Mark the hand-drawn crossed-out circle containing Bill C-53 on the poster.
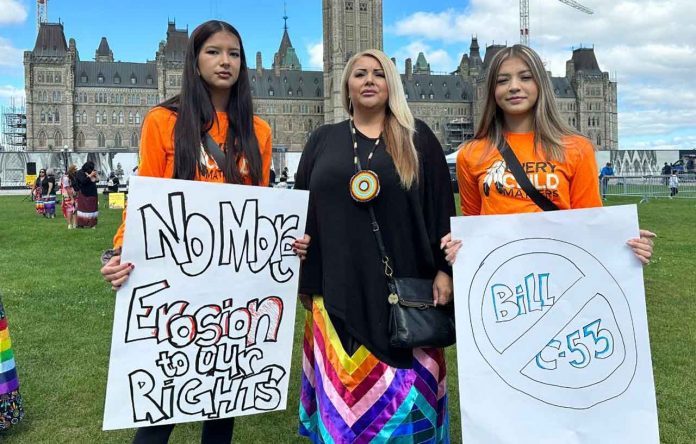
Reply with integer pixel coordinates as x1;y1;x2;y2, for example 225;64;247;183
469;238;637;409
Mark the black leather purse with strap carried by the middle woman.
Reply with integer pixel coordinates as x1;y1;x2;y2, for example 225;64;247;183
368;205;456;349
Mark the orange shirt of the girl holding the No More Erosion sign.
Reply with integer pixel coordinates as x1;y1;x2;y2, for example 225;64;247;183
114;106;272;248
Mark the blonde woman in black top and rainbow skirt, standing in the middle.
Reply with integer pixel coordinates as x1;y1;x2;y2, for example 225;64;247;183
295;50;454;443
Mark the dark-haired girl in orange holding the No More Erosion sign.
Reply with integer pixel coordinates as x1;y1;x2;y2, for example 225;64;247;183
101;20;308;444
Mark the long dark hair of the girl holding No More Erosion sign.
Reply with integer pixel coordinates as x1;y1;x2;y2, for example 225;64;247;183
160;20;261;185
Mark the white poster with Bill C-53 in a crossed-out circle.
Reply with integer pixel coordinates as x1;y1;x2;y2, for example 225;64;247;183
452;205;659;444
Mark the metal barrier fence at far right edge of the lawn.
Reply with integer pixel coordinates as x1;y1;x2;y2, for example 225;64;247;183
600;173;696;202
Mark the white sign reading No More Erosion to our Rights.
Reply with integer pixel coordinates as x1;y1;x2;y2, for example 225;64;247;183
103;177;309;430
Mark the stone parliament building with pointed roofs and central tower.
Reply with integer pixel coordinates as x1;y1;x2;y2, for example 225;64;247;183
14;0;618;180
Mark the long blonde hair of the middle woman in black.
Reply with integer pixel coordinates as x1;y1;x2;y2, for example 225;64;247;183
341;49;418;189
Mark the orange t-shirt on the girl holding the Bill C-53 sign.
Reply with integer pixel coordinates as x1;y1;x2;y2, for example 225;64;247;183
457;132;602;216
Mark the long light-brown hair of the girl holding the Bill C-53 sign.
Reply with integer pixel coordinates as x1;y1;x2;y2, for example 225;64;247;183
474;44;579;161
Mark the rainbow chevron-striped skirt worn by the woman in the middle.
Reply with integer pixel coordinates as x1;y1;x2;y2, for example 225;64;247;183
299;296;449;443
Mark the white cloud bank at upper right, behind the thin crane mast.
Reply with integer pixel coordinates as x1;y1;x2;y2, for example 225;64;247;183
385;0;696;148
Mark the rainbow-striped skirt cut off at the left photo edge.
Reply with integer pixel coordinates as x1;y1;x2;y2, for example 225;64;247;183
0;299;24;430
